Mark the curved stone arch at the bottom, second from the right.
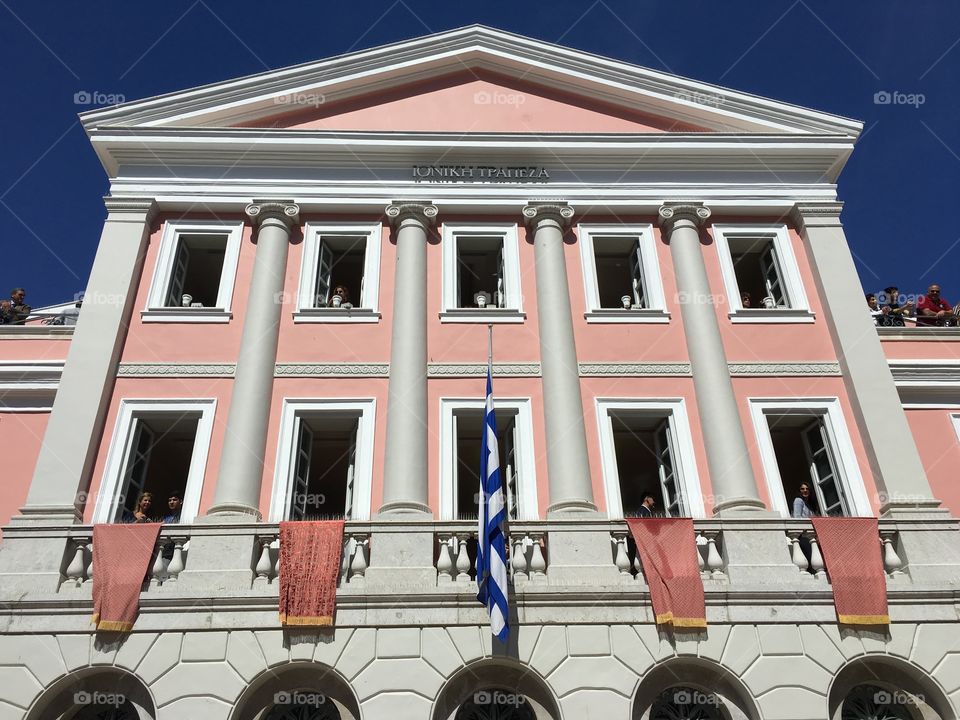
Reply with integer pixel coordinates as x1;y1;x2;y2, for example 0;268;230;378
630;657;760;720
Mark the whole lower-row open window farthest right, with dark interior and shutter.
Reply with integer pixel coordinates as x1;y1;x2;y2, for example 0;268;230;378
750;399;871;517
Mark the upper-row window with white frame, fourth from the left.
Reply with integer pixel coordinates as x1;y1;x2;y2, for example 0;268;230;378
578;224;670;323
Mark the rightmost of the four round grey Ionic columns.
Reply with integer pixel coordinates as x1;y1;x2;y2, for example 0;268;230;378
659;204;764;515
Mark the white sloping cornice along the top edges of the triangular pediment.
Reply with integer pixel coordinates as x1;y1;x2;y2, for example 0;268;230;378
81;25;862;138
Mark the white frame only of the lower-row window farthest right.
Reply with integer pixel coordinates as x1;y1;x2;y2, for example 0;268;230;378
748;397;874;518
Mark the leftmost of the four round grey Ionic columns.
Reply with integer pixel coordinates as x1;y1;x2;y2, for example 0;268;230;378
208;200;300;520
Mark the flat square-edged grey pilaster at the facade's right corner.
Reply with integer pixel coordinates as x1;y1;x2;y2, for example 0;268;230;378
794;202;940;515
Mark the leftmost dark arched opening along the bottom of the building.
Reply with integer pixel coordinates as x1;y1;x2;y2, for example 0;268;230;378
24;667;157;720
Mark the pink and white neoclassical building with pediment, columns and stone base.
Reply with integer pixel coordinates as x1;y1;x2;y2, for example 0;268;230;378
0;27;960;720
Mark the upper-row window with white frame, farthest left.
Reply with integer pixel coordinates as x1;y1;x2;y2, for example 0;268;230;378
142;221;243;322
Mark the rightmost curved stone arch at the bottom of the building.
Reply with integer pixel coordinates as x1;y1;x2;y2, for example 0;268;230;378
827;655;957;720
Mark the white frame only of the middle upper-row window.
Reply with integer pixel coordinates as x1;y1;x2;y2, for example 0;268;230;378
440;223;526;323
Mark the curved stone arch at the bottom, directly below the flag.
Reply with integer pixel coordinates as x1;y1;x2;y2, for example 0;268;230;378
430;658;563;720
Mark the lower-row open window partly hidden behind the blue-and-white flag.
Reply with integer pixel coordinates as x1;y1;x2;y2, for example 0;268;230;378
440;399;539;520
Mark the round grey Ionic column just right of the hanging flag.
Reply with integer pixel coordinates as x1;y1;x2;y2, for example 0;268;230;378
523;202;597;515
